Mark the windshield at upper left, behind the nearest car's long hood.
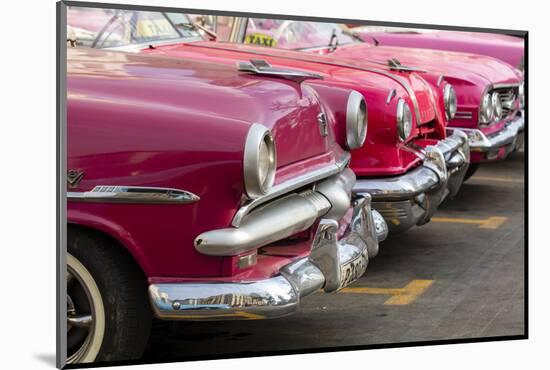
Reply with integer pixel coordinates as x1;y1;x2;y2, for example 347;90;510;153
67;7;202;48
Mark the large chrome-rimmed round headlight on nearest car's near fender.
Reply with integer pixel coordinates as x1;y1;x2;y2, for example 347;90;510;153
243;123;277;198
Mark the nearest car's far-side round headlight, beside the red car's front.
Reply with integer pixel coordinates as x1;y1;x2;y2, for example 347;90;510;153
346;91;368;149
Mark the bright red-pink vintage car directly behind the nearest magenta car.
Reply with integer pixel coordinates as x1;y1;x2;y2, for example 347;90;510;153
69;7;469;237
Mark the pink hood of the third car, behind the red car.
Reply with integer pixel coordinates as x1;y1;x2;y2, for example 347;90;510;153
335;44;519;86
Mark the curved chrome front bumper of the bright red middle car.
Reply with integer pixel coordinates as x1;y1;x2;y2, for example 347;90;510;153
353;146;453;233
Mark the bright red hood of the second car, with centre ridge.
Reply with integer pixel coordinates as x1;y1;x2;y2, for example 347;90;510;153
143;42;437;123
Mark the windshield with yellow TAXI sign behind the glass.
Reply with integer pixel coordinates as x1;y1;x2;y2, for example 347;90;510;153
244;18;359;49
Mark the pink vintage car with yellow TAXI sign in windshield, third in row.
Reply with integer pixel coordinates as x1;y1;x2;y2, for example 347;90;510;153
230;18;524;178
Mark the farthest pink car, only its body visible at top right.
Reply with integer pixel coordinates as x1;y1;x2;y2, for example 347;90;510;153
350;25;525;71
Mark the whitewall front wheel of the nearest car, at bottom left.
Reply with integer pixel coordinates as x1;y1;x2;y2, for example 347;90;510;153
67;232;152;364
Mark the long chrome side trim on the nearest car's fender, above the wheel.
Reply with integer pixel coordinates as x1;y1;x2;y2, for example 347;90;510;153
67;185;200;204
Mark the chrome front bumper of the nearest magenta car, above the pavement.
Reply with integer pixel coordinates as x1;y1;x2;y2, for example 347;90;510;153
149;195;384;320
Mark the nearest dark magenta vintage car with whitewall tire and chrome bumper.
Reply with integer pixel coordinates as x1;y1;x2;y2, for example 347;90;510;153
67;44;387;363
